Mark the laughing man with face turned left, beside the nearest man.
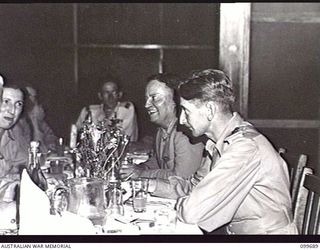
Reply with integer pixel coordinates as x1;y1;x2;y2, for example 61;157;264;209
122;73;203;180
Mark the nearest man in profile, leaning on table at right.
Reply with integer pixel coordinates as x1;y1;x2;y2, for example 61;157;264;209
168;69;297;234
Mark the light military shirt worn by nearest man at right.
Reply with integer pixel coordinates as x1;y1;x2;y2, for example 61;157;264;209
177;113;297;234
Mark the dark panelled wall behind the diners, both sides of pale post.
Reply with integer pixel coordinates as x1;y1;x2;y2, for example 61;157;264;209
0;3;320;174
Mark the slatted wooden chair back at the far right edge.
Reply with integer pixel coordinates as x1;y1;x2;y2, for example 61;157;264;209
301;174;320;234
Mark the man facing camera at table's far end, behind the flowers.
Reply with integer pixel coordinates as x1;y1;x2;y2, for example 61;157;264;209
76;77;138;141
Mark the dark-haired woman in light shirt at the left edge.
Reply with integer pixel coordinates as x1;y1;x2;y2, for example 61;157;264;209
0;85;30;201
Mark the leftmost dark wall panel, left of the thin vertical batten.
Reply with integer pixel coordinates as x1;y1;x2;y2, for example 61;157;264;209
0;4;74;140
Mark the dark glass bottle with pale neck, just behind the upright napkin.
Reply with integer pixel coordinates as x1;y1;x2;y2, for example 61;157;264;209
28;141;48;190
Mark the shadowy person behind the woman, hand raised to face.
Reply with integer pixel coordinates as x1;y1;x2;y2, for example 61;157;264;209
17;86;58;152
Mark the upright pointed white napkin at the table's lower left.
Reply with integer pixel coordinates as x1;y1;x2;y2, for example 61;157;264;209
19;169;96;235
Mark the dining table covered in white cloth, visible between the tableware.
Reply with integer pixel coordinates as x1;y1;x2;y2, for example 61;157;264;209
7;148;202;235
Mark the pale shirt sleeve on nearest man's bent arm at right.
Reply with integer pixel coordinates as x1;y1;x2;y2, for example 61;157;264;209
177;138;260;231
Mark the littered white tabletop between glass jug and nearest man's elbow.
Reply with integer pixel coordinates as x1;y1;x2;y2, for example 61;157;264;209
96;195;202;235
